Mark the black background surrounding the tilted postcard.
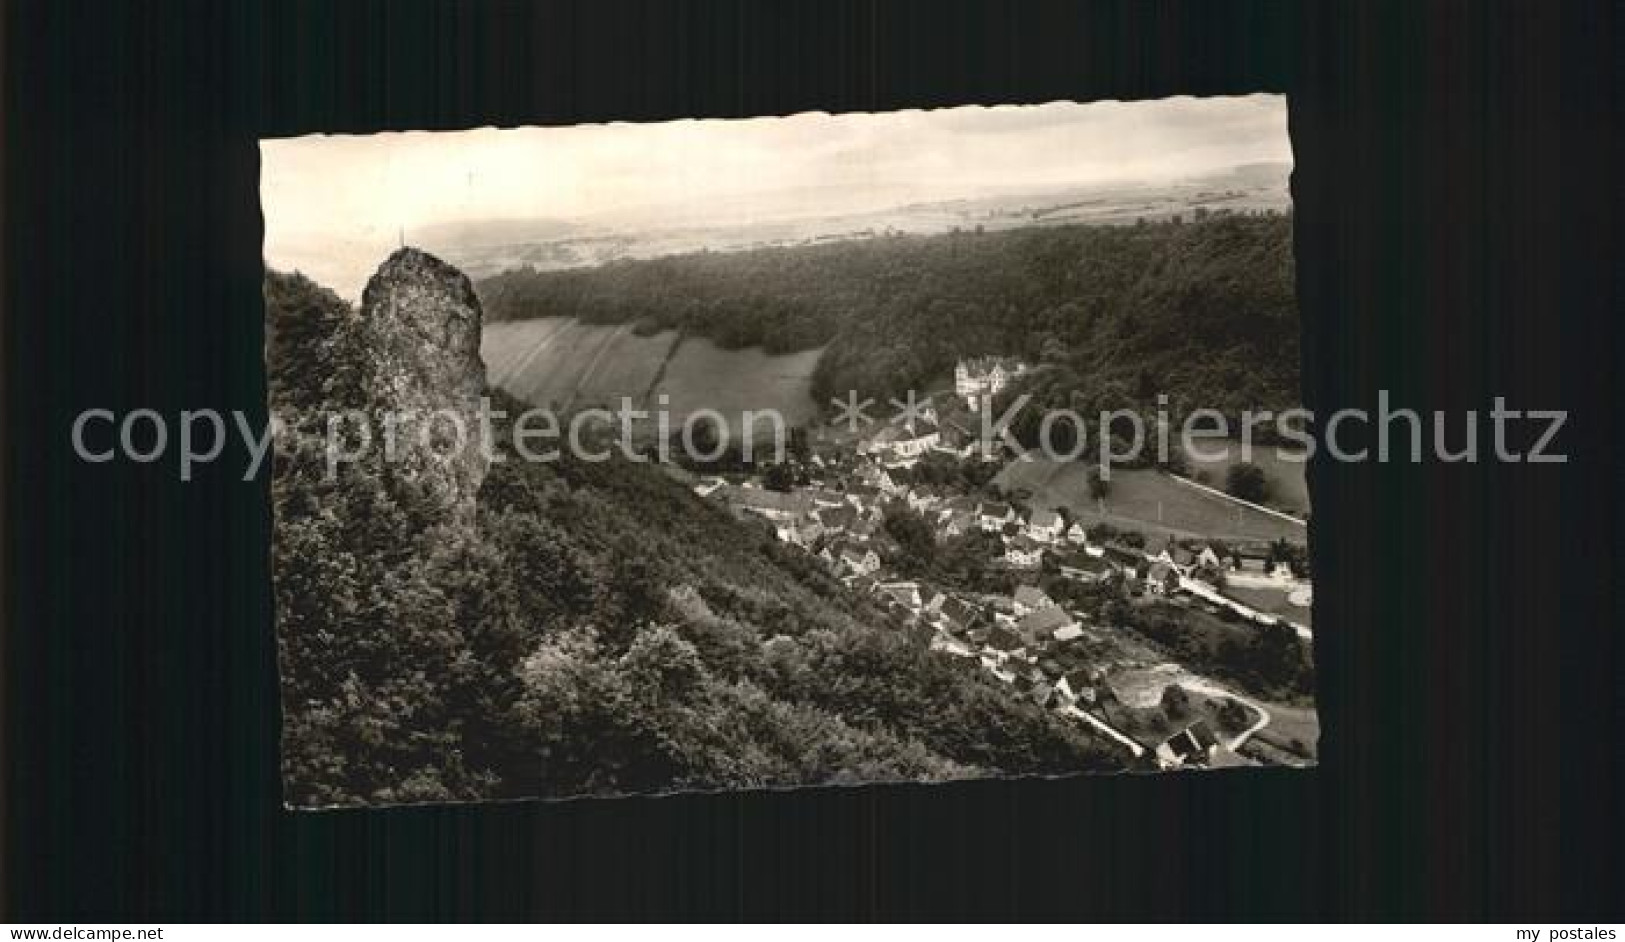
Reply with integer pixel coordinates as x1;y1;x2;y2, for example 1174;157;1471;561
3;0;1625;921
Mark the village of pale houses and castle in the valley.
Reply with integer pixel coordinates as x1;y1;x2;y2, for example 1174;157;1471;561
692;357;1318;768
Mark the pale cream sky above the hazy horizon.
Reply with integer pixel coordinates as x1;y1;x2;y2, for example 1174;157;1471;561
260;94;1292;293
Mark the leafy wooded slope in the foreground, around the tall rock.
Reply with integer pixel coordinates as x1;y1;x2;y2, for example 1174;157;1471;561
265;266;1118;806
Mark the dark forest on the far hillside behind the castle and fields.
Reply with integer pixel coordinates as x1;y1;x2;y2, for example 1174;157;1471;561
479;214;1300;416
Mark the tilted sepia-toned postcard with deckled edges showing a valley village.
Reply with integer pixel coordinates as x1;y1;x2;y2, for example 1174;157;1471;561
260;94;1320;807
